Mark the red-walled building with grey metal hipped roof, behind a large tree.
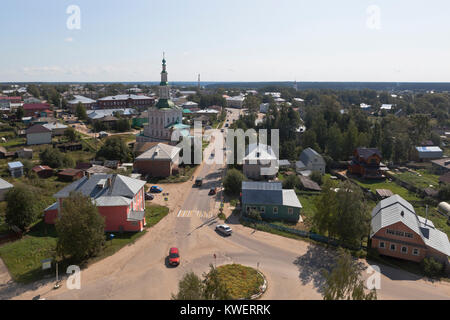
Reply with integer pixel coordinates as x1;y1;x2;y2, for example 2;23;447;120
44;174;146;232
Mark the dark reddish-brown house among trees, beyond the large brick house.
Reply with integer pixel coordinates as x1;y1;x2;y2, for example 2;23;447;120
348;148;383;179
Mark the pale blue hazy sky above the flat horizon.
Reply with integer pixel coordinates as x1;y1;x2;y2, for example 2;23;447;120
0;0;450;83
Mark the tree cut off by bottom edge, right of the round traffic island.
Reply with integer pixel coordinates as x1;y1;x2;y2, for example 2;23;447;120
322;248;377;300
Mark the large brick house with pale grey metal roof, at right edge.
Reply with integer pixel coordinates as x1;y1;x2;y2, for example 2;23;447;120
370;195;450;268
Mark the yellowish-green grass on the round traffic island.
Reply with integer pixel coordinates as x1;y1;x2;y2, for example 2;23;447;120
217;264;264;300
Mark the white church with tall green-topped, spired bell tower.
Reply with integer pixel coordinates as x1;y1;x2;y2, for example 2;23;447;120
136;57;189;144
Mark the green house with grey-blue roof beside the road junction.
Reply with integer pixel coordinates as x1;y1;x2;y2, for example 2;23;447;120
242;181;302;222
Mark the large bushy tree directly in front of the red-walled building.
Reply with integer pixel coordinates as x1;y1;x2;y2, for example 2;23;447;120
55;193;105;262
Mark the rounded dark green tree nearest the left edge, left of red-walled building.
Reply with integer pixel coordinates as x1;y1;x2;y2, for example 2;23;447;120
5;184;40;230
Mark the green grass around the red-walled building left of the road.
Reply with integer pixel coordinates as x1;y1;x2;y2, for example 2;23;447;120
0;205;169;283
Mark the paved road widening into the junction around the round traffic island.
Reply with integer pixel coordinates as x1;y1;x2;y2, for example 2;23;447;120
0;107;450;300
